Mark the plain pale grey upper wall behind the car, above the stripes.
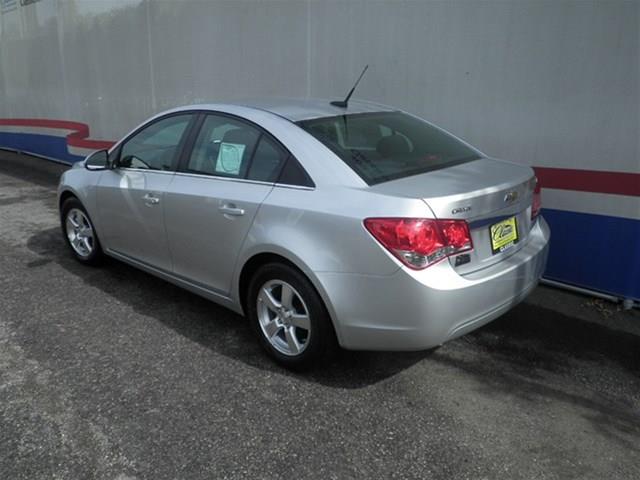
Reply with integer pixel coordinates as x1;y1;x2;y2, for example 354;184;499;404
0;0;640;172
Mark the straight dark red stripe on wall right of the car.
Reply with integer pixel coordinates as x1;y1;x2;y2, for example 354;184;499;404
533;167;640;197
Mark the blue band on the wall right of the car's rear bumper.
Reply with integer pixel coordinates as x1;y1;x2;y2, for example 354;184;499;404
542;208;640;300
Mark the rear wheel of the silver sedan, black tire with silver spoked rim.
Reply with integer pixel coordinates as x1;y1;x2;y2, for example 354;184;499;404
246;263;337;370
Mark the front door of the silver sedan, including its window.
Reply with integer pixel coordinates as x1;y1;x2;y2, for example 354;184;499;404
97;113;195;271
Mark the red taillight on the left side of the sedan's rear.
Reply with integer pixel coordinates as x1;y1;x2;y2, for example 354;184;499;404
364;218;473;269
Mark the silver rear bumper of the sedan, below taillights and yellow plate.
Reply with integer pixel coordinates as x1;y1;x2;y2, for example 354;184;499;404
317;217;550;350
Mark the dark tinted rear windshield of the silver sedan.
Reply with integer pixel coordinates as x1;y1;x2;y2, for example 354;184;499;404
298;112;480;185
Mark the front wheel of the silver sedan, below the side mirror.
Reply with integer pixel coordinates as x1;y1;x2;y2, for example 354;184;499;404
60;197;104;265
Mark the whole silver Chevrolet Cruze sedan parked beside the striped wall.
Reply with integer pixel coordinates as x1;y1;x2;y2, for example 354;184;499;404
58;100;549;368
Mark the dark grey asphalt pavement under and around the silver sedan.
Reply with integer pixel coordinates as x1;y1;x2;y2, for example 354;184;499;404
0;152;640;480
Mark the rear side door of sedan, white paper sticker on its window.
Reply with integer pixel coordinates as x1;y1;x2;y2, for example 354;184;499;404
165;114;287;295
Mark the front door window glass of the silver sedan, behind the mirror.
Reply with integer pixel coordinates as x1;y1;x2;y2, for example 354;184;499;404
118;114;192;170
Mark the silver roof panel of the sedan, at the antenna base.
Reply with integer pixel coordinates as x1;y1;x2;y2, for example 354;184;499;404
174;98;397;122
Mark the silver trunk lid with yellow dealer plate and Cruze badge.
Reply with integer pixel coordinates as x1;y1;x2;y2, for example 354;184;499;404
372;158;535;275
